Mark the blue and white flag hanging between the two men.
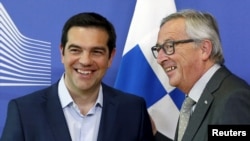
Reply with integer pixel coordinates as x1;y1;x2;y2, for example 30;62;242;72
115;0;184;139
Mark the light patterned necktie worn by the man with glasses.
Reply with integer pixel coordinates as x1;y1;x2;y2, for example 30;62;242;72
178;96;195;141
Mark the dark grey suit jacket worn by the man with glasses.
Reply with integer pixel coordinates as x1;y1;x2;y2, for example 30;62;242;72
156;66;250;141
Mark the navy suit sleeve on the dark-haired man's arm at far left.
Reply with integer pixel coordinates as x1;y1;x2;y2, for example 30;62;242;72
0;100;24;141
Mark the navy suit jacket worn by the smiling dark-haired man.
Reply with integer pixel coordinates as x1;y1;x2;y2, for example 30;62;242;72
1;83;153;141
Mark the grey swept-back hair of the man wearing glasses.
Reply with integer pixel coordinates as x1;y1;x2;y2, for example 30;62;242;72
160;9;225;65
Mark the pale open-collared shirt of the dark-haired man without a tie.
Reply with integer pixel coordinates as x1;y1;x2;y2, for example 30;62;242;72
58;75;103;141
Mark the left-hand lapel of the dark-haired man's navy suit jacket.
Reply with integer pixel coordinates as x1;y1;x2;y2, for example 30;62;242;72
44;83;71;141
